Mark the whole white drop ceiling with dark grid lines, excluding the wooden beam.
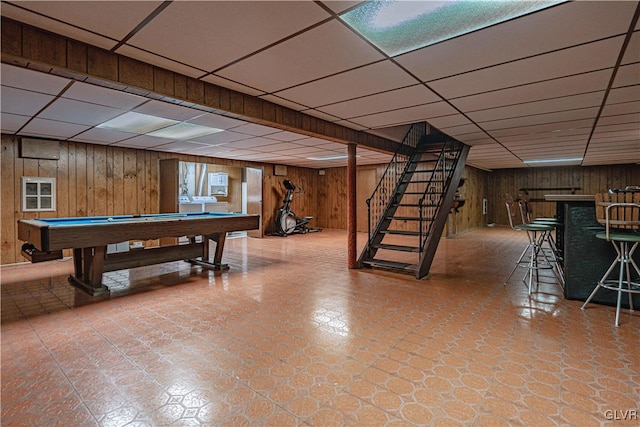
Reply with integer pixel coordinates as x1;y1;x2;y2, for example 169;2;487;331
1;1;640;169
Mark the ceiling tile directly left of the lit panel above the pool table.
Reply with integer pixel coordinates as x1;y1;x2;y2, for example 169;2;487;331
38;98;125;126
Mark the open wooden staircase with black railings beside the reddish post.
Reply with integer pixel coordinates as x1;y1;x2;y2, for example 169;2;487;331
358;123;469;279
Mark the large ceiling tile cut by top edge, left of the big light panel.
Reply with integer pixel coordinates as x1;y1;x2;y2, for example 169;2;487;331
129;1;330;72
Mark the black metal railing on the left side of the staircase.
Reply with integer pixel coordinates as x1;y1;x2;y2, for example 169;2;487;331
366;122;427;256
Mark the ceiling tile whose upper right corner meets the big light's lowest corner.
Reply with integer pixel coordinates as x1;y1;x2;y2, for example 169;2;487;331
276;61;416;108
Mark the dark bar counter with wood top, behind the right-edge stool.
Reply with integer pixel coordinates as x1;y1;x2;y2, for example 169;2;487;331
545;194;640;308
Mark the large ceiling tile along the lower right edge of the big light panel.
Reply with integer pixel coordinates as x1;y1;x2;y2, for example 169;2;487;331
395;2;635;83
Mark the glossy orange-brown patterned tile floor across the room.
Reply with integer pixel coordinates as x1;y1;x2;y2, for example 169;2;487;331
1;228;640;427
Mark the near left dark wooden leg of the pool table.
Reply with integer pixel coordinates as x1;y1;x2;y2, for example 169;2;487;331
69;246;109;296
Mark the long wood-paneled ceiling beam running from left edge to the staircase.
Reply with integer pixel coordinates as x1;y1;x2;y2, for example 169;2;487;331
1;17;398;153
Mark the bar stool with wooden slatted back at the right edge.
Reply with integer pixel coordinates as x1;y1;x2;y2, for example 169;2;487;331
581;193;640;326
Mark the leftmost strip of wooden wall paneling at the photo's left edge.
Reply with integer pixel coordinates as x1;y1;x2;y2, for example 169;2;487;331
0;136;18;264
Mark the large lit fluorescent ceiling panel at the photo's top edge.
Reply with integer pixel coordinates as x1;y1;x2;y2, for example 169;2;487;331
340;0;564;56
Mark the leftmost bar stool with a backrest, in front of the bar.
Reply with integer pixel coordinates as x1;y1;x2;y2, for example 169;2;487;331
504;194;553;295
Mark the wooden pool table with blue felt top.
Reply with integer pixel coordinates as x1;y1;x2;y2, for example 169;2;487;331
18;212;260;295
